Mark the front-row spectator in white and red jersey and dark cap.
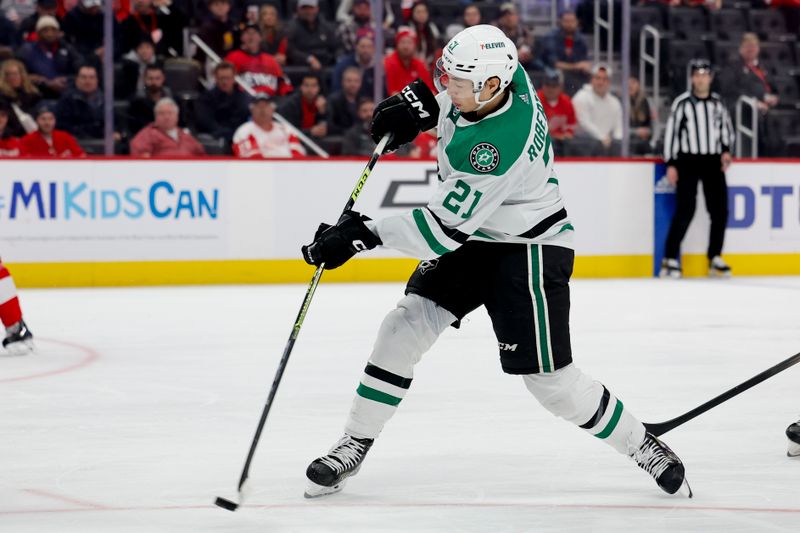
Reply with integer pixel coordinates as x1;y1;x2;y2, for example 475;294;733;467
233;93;306;158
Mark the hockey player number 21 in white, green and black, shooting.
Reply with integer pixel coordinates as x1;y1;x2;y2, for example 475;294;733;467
302;25;691;497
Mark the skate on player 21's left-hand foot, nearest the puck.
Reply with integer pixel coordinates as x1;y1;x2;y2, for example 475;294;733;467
305;433;373;498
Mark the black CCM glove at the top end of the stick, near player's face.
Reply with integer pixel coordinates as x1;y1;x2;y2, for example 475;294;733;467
370;78;439;152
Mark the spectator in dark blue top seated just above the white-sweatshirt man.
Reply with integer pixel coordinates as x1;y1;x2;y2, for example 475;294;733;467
541;11;592;92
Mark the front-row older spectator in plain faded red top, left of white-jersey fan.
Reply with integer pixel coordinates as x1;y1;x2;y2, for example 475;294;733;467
131;98;206;157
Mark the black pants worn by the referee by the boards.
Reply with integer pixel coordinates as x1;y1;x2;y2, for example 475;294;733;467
664;155;728;259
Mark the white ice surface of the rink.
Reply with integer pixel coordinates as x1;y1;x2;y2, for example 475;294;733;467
0;278;800;533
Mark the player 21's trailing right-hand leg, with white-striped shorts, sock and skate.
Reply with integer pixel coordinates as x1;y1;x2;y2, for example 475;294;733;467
487;245;691;494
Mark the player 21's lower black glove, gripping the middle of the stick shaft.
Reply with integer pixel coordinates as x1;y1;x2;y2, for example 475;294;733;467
301;211;383;270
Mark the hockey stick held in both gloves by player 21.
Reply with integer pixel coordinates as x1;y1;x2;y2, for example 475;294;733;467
214;134;390;511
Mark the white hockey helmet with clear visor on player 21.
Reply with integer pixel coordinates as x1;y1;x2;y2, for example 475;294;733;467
434;24;518;109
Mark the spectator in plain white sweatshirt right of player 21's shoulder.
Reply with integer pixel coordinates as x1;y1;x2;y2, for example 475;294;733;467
572;63;622;155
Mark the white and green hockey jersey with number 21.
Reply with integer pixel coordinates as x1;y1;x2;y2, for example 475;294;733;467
367;66;574;259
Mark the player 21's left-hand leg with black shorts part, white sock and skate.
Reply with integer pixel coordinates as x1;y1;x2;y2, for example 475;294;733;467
305;249;478;498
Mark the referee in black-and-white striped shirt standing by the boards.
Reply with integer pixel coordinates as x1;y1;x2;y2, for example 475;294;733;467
659;59;734;278
